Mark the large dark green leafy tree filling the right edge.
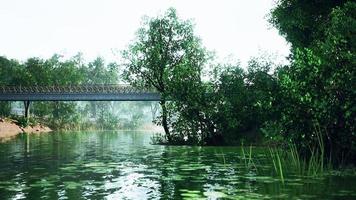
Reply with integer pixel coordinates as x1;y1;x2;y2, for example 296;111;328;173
272;0;356;163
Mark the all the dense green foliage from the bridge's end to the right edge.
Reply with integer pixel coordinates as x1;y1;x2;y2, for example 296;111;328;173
124;5;356;167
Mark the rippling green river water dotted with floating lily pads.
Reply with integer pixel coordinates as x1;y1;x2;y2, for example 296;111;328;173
0;131;356;200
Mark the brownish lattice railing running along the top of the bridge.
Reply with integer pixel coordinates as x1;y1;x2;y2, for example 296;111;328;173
0;84;156;94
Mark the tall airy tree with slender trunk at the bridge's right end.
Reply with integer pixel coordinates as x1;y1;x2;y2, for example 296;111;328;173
123;9;207;141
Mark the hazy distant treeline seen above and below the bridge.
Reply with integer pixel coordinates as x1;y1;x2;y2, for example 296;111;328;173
0;54;156;129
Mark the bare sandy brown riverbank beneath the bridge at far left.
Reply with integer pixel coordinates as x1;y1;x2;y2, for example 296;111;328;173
0;118;52;140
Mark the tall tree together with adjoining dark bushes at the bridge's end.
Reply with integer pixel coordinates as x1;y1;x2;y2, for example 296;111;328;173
123;9;277;145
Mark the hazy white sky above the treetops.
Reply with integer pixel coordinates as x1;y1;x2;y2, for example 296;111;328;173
0;0;289;64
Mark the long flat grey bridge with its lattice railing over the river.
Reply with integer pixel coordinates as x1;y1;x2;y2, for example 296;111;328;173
0;85;160;101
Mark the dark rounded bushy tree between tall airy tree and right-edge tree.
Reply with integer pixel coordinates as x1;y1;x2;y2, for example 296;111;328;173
212;56;278;143
